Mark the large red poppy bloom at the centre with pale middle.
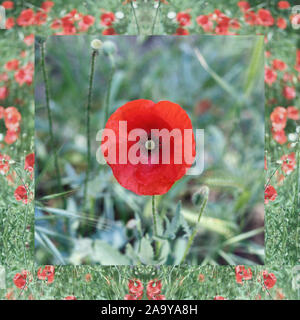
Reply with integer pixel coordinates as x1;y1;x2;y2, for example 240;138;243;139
101;99;196;195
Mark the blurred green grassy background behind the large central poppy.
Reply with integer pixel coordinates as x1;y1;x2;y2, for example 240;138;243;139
35;36;264;265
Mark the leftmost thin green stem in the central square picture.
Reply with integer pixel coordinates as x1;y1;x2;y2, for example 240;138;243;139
40;39;66;209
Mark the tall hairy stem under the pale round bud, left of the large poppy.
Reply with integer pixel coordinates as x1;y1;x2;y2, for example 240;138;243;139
83;49;98;207
